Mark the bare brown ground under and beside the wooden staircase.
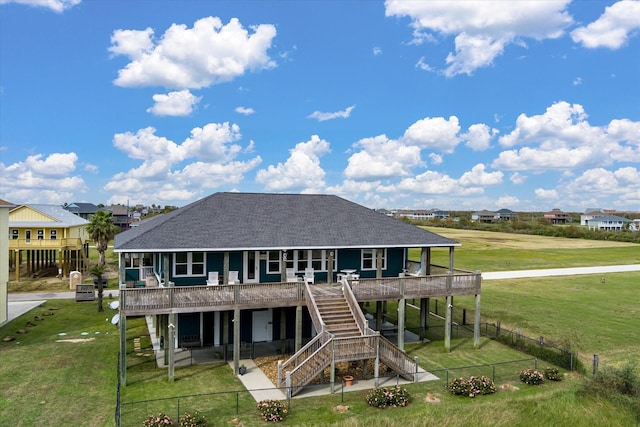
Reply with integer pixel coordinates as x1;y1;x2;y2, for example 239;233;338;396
254;355;390;384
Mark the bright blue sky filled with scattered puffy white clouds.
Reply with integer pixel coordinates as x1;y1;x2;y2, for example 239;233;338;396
0;0;640;211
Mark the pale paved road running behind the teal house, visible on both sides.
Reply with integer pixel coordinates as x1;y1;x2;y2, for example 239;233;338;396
2;264;640;320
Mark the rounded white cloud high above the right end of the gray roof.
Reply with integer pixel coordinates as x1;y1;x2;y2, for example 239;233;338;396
401;116;460;153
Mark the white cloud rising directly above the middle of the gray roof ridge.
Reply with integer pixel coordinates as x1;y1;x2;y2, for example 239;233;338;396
256;135;330;192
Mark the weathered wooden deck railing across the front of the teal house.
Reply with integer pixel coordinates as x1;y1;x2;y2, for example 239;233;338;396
120;273;481;316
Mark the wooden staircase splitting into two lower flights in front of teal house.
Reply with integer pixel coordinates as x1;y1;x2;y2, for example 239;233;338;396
277;284;418;395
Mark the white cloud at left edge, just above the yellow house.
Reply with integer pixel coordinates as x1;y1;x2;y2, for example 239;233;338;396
0;153;86;204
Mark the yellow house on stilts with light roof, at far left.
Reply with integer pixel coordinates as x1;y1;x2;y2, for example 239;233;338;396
9;204;89;281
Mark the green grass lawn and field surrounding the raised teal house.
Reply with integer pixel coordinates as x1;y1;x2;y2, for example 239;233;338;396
0;229;640;427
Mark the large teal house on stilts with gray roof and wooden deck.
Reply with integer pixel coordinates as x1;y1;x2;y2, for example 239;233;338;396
114;193;481;392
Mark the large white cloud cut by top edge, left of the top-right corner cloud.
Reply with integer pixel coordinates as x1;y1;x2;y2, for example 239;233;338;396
385;0;573;77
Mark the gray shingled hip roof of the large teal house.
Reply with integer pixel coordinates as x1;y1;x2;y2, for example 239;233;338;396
114;193;460;252
